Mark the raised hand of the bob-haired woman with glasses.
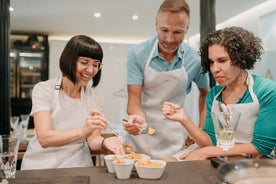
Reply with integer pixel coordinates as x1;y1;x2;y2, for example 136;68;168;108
82;109;109;137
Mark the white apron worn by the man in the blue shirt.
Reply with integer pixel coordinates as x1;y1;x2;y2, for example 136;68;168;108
128;41;188;159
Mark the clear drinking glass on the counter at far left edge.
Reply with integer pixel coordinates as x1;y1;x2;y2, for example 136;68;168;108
0;135;19;179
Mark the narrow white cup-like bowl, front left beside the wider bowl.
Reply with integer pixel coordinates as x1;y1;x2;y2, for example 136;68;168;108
113;159;134;179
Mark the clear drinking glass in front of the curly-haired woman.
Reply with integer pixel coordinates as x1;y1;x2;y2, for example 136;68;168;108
211;111;241;158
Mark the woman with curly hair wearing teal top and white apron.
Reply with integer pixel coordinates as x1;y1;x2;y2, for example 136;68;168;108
162;27;276;160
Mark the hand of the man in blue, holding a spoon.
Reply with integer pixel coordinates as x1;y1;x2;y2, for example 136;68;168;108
123;115;148;135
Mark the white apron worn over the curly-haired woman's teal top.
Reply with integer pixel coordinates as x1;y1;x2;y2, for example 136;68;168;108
211;73;260;144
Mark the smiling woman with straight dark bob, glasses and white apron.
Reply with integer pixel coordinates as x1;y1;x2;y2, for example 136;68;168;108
21;35;124;170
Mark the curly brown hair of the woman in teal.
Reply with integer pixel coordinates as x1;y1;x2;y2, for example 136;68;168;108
200;27;264;73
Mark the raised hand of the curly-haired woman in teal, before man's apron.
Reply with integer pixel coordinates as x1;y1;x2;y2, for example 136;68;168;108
162;101;188;122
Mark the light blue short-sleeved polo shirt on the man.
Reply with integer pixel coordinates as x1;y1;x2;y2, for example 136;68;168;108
127;36;209;93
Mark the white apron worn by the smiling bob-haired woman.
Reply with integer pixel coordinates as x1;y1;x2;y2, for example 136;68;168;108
22;77;93;169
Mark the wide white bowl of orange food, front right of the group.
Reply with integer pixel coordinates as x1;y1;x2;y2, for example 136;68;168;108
135;160;166;179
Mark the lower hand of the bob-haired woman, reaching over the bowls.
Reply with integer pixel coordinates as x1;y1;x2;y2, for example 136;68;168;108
103;136;125;155
